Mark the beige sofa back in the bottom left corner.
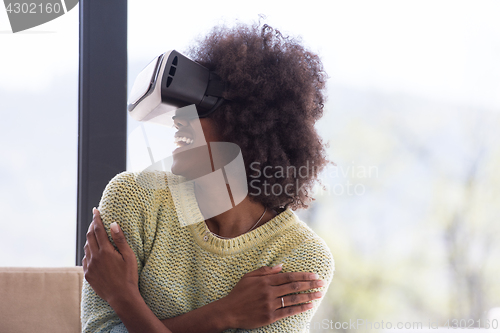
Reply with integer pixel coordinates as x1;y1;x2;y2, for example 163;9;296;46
0;266;83;333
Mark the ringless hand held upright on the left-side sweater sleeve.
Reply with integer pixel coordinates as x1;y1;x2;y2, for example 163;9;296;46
82;208;139;304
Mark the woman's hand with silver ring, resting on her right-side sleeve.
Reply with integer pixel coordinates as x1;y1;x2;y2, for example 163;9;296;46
221;265;325;329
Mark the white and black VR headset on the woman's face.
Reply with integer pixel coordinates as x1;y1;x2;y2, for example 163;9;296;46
128;50;226;126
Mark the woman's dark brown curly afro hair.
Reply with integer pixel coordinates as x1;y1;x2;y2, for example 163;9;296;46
188;23;329;212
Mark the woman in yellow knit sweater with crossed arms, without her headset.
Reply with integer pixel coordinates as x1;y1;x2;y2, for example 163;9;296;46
82;21;334;332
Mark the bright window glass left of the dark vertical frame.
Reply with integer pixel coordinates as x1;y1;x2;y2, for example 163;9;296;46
0;6;78;266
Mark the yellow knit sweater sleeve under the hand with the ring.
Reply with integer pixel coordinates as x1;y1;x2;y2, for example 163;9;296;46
232;238;335;333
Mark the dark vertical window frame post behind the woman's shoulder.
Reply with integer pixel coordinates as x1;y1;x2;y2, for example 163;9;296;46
76;0;127;266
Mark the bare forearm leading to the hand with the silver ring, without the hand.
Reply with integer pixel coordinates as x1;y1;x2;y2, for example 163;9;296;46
161;299;231;333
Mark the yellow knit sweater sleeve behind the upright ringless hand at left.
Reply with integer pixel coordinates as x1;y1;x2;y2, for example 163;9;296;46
81;173;155;333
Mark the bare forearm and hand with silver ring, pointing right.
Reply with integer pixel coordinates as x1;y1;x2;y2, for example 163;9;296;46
156;265;324;333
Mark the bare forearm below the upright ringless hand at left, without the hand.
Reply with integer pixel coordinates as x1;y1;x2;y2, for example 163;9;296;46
109;291;172;333
